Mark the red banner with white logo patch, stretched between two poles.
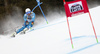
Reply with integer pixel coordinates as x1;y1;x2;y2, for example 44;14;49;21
63;0;89;17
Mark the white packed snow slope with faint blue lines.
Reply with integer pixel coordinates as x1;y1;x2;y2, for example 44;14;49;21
0;6;100;54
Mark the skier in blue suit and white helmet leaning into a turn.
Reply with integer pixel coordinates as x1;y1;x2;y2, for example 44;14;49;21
11;8;35;37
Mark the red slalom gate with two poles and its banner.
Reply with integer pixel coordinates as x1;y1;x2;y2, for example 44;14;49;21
63;0;98;48
